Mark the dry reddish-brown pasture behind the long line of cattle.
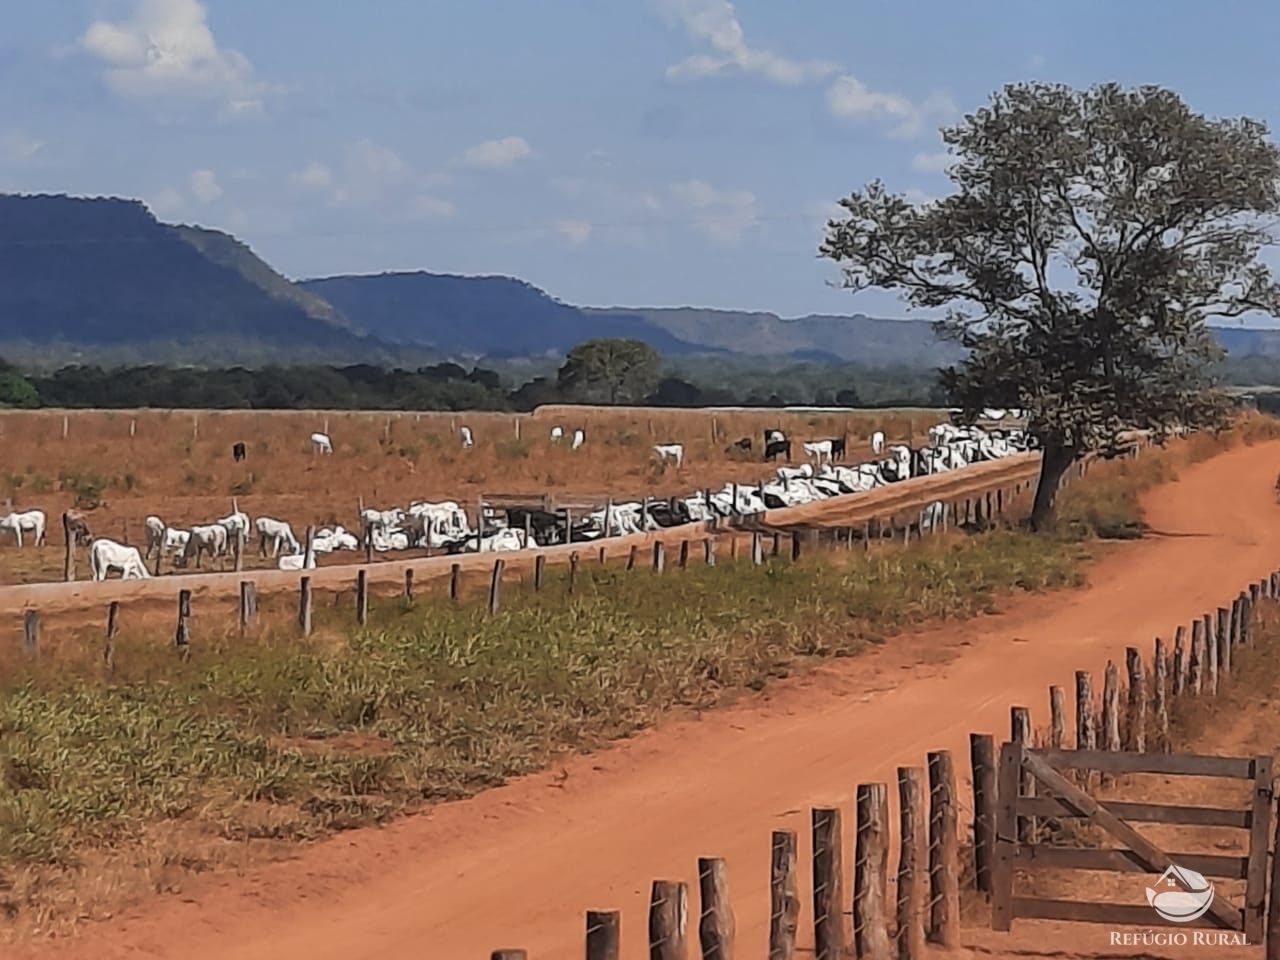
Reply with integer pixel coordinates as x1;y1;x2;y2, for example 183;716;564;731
0;407;947;584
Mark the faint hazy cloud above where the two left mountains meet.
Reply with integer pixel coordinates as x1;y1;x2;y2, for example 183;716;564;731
288;140;456;220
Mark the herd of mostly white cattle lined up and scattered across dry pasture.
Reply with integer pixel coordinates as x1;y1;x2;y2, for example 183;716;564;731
0;411;1036;580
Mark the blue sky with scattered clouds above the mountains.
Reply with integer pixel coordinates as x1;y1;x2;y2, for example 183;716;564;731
0;0;1280;323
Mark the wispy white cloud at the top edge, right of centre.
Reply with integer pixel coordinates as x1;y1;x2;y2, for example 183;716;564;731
654;0;840;87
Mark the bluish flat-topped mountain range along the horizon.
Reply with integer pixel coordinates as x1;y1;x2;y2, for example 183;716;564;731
0;195;1280;367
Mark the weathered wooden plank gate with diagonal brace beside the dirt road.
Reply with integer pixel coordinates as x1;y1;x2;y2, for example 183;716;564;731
991;742;1272;943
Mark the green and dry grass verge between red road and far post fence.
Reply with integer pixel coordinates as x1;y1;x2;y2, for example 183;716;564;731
0;433;1252;937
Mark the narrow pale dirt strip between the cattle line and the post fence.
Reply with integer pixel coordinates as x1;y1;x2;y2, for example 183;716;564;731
0;453;1059;608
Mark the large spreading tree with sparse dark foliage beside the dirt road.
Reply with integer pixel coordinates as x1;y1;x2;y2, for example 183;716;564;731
819;83;1280;530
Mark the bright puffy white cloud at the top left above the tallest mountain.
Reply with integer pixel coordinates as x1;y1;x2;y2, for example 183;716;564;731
79;0;266;114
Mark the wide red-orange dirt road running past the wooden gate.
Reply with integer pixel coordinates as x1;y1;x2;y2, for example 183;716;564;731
10;443;1280;960
